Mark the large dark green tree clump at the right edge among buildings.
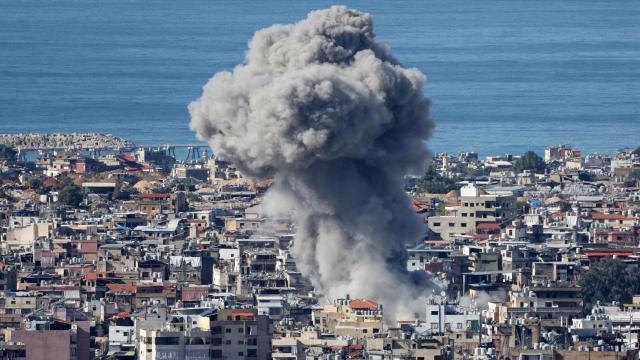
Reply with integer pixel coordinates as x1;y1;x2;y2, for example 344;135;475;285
579;258;640;309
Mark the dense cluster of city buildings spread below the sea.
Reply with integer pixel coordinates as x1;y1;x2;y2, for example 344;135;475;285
0;136;640;360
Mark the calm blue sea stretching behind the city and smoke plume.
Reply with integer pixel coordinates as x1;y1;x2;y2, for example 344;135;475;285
0;0;640;155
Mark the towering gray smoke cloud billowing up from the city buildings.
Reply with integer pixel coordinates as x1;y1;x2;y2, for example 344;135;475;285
189;6;435;319
